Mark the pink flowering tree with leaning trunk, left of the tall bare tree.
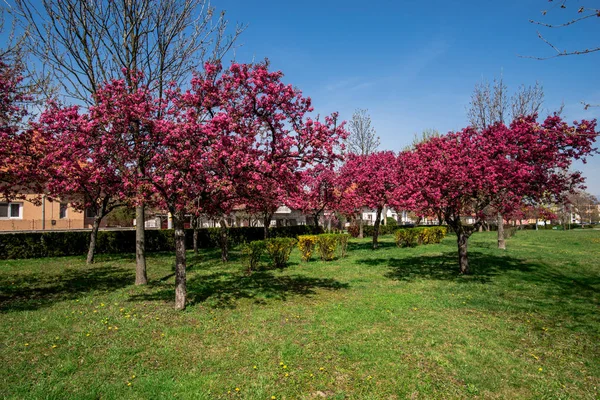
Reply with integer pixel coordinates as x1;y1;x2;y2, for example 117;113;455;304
32;103;125;264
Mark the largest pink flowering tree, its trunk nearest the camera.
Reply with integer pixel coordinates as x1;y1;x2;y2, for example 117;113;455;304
83;64;346;309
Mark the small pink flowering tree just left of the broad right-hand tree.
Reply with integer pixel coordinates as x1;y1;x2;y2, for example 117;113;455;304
339;151;403;249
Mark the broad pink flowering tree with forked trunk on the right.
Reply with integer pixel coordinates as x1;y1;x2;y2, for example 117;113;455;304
406;116;597;274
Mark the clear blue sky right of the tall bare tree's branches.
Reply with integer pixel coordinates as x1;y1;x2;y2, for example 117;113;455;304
219;0;600;195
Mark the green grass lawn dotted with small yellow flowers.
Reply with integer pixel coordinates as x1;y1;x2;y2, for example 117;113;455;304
0;230;600;399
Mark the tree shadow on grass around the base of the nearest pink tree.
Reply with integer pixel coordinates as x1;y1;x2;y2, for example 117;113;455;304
130;271;349;308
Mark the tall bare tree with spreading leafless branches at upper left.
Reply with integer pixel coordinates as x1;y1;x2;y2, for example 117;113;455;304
12;0;245;284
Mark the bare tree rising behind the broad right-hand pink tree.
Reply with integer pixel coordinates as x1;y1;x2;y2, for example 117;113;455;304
467;75;548;249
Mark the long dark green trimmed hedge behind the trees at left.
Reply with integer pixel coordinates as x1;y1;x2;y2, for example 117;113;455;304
0;225;322;260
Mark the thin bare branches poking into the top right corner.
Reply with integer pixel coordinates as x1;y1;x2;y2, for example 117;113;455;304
525;0;600;60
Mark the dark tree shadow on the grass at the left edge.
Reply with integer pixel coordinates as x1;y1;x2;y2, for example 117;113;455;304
0;266;134;313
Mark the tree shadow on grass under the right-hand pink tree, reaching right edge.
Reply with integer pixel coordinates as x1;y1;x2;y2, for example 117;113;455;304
358;251;600;332
